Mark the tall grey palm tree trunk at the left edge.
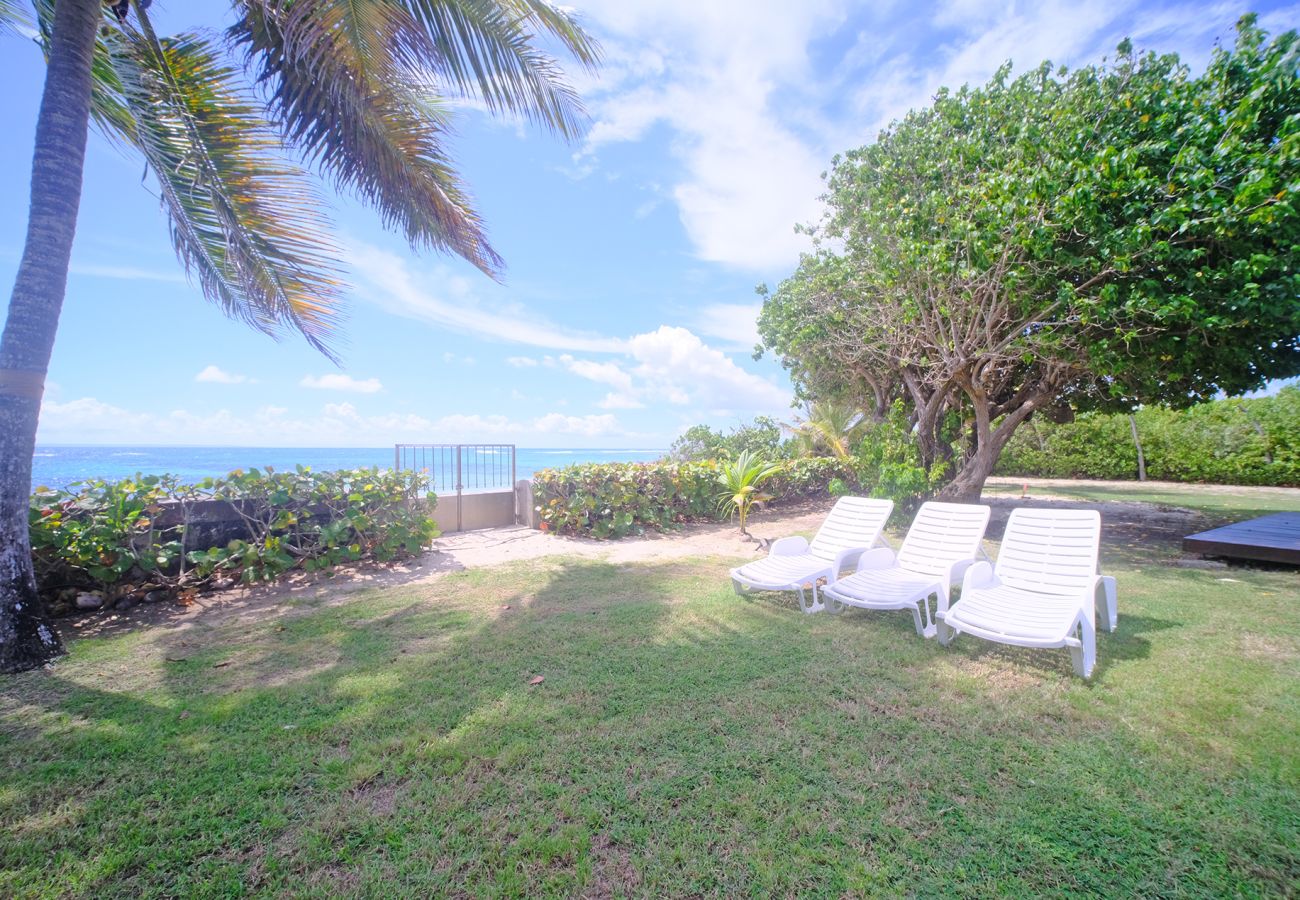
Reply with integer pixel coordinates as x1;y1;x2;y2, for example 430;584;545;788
0;0;104;672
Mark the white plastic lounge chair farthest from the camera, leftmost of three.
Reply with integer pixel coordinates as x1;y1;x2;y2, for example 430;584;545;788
731;497;893;613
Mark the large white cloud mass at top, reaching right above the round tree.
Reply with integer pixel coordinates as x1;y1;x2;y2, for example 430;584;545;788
577;0;1268;273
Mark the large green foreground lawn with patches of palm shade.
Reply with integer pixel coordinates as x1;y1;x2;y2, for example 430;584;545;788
0;522;1300;897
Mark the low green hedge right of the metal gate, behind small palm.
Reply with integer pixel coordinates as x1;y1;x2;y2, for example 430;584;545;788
533;458;857;538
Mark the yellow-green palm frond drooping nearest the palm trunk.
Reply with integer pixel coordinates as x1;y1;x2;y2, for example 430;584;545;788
96;20;341;359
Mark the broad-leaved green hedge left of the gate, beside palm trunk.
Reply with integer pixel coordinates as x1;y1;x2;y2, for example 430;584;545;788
29;466;438;608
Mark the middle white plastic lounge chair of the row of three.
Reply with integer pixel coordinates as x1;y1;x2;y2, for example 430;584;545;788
822;502;991;637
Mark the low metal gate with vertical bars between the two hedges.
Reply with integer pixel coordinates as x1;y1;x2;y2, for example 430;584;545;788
393;443;519;531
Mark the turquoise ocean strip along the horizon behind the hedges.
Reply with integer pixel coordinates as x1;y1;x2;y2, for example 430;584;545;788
31;445;667;488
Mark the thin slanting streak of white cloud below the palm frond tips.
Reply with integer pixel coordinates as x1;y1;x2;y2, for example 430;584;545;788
348;242;621;352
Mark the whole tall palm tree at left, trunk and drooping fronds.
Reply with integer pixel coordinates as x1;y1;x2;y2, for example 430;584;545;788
0;0;599;672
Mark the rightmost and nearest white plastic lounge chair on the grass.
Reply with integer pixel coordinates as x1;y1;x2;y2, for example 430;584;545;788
935;509;1114;678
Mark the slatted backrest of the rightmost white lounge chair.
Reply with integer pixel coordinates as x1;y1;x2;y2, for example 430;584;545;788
993;509;1101;596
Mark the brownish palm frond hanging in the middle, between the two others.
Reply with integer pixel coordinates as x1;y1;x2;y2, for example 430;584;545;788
229;0;502;277
